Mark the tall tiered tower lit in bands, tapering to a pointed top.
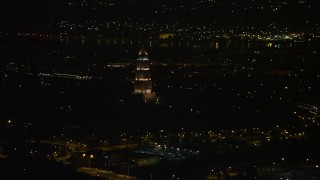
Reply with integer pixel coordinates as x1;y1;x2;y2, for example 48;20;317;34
134;48;156;101
